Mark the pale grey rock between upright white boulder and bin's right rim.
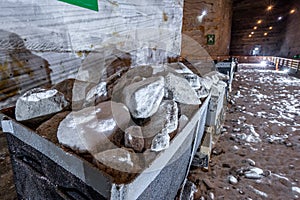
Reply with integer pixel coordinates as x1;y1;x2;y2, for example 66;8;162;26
165;73;201;105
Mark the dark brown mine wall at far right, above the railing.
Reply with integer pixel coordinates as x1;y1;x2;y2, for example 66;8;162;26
279;0;300;58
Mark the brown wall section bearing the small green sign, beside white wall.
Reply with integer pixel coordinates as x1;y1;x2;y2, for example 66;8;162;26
182;0;232;59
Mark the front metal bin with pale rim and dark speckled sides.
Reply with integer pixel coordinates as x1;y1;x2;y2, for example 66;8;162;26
0;96;210;200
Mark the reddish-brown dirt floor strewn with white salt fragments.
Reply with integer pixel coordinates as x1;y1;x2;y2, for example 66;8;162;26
0;65;300;200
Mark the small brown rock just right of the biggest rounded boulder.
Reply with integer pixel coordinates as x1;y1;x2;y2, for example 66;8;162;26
124;126;144;152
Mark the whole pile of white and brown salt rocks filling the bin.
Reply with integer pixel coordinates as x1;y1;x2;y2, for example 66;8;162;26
15;63;228;171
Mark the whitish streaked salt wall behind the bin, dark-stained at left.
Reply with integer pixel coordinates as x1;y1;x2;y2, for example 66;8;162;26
0;0;183;107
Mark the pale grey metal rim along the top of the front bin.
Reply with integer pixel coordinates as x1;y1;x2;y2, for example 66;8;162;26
0;95;210;199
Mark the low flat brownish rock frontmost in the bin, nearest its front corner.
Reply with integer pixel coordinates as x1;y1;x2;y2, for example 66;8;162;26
93;148;141;173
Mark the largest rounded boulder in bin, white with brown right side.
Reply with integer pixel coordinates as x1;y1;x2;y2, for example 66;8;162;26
57;101;131;153
